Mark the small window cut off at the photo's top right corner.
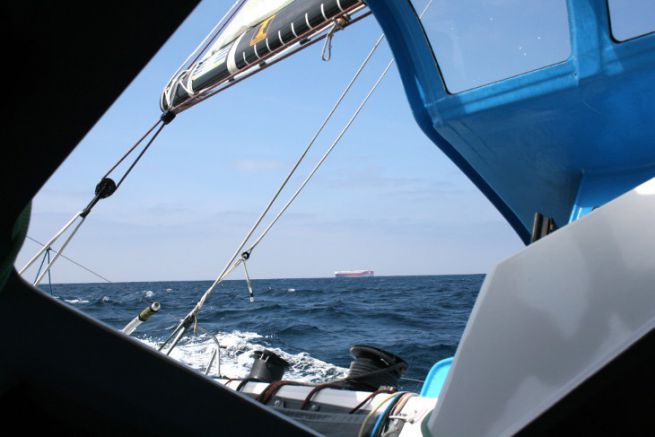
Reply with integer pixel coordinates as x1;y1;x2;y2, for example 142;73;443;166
607;0;655;41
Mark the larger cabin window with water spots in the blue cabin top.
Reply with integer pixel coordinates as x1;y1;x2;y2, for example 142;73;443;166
412;0;572;93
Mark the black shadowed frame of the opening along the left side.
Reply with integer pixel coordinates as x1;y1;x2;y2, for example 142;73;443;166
0;0;313;436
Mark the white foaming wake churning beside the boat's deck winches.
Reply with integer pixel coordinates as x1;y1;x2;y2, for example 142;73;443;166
141;331;348;383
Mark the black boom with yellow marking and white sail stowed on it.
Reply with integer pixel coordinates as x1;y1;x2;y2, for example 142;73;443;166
161;0;363;111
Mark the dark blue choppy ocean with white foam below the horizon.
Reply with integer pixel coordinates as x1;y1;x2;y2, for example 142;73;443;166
43;275;484;391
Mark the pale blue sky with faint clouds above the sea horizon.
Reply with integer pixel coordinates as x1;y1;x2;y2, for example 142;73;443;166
17;1;523;283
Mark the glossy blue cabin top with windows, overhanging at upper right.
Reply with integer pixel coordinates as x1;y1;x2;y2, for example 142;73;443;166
367;0;655;243
